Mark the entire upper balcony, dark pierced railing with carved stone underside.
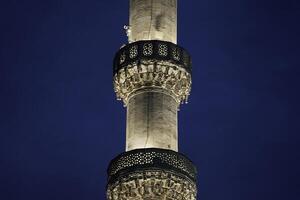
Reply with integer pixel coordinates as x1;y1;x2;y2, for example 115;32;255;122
114;40;191;105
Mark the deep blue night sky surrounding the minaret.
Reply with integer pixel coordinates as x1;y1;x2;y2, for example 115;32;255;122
0;0;300;200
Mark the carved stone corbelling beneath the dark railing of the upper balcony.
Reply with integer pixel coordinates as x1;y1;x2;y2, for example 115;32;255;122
114;60;191;106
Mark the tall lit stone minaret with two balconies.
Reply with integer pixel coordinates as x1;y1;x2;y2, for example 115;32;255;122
107;0;197;200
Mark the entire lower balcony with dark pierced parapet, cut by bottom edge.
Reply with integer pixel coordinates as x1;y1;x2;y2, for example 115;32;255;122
107;148;197;200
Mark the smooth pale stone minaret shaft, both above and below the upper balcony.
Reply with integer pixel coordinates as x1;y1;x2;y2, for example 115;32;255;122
126;0;183;151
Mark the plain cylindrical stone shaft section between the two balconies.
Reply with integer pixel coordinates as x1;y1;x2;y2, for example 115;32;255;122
126;88;178;151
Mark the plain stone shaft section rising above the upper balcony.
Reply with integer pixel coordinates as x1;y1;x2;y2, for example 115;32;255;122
129;0;177;44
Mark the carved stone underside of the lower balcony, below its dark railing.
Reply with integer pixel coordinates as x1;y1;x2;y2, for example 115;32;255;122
107;170;197;200
